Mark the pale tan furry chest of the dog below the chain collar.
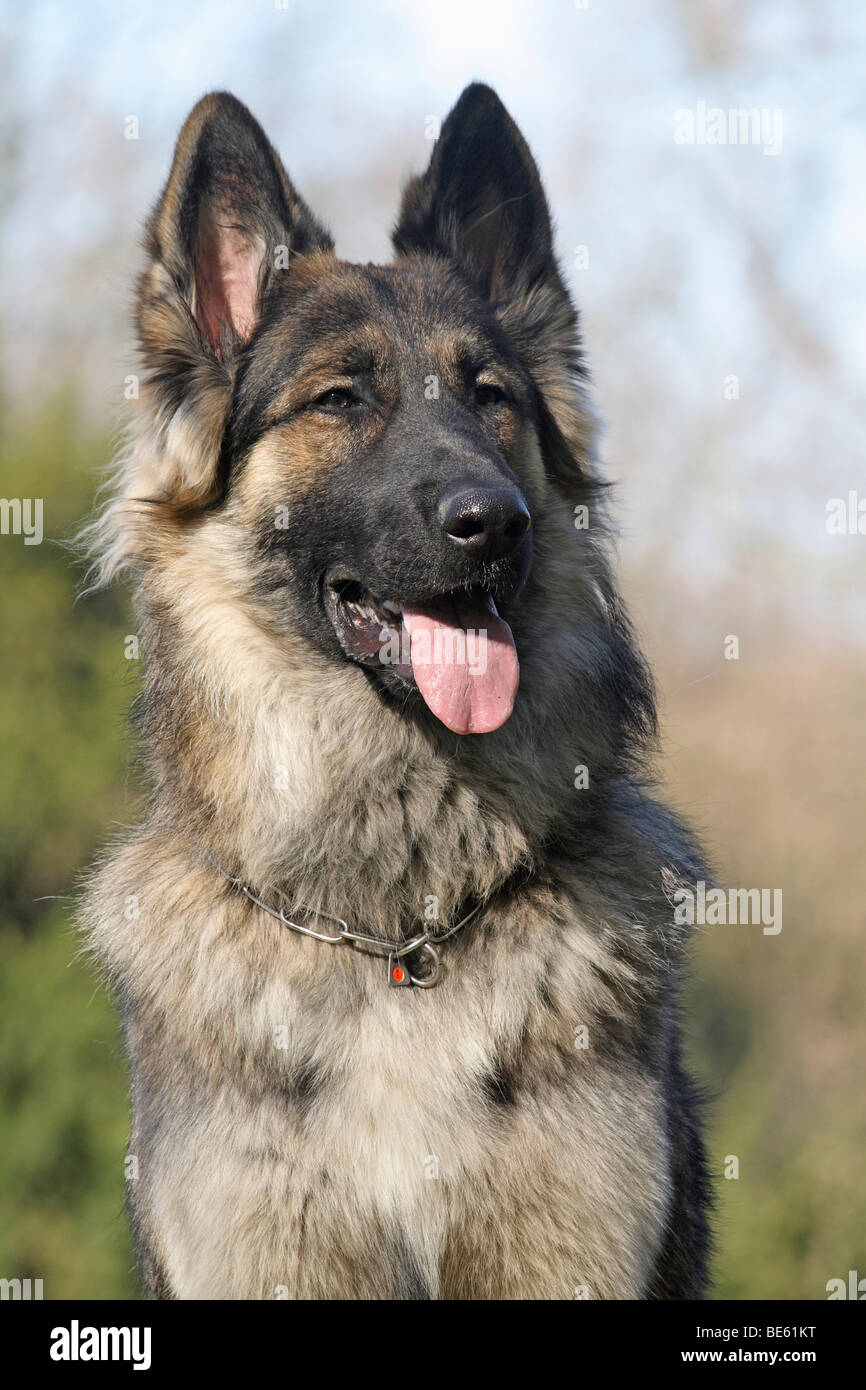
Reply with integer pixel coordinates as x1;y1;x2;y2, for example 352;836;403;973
152;917;667;1297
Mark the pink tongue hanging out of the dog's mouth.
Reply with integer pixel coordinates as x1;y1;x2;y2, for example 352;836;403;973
403;595;520;734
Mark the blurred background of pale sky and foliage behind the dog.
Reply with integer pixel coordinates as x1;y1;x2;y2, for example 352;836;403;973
0;0;866;1298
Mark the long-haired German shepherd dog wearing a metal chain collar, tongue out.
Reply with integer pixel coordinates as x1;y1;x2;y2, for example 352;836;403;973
83;85;709;1300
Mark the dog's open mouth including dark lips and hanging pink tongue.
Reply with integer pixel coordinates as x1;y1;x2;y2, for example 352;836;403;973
324;578;520;734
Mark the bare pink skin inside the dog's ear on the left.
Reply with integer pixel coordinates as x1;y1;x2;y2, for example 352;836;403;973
195;210;263;357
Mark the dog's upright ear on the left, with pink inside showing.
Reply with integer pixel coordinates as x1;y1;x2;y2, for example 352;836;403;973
138;92;334;505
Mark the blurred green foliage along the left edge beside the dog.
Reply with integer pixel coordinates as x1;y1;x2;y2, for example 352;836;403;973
0;399;136;1298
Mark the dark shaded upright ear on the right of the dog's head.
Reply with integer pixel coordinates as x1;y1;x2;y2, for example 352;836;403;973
393;82;594;489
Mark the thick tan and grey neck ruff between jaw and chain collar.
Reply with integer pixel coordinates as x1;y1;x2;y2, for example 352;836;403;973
140;519;647;935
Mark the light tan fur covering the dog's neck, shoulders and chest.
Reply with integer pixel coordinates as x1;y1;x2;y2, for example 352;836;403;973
88;469;683;1298
